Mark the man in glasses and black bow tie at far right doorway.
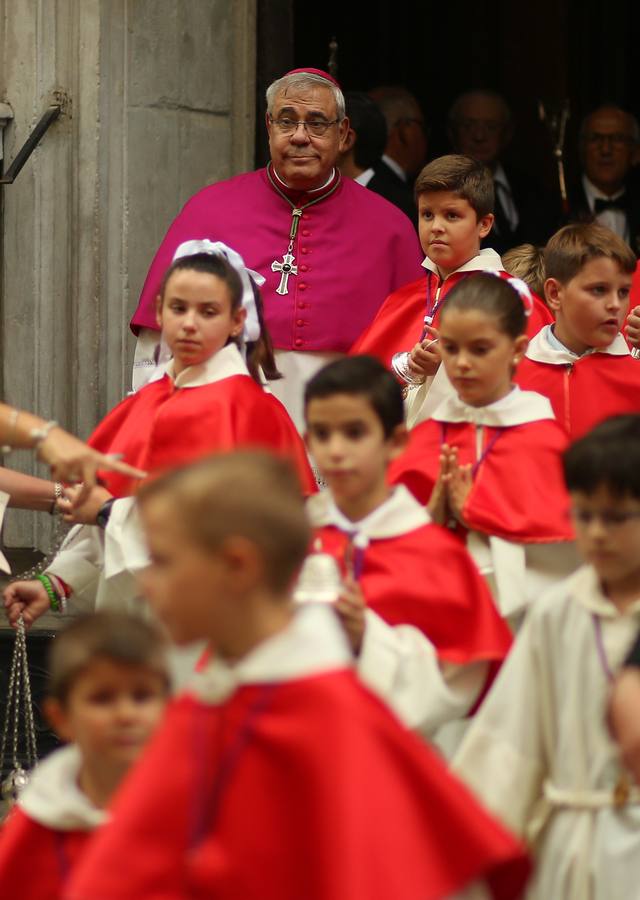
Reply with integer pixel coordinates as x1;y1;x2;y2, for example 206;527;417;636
569;106;640;254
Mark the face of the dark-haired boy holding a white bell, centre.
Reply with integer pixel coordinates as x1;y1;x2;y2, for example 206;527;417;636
306;394;405;515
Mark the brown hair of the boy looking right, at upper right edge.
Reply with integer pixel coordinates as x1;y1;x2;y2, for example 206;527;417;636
544;222;636;284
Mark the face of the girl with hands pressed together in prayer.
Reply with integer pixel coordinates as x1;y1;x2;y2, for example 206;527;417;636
440;308;528;406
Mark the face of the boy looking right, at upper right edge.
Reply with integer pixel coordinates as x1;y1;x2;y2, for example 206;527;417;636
545;256;631;354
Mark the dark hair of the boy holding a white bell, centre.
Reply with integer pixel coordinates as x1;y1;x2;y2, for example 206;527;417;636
304;356;404;438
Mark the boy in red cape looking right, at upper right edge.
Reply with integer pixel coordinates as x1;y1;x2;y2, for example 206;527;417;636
516;223;640;439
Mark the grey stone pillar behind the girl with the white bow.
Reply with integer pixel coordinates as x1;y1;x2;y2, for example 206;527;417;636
0;0;256;547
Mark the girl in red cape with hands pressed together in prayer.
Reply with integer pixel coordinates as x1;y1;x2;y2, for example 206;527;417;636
390;275;578;626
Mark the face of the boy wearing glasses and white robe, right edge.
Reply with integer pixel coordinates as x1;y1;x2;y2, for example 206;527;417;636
571;485;640;596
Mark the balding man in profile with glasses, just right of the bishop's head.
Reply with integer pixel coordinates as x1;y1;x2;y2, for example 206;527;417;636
368;86;427;228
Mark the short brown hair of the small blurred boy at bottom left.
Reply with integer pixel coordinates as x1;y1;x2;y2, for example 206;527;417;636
48;612;170;704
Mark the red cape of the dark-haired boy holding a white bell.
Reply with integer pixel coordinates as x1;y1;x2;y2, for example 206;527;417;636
314;525;511;665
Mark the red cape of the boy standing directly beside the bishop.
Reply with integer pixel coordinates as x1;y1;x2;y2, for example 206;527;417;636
351;271;553;367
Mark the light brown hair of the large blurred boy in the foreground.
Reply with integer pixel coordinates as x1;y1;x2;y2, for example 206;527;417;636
138;450;311;592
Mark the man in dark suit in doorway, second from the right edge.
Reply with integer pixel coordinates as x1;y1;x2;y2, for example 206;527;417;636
448;91;554;254
